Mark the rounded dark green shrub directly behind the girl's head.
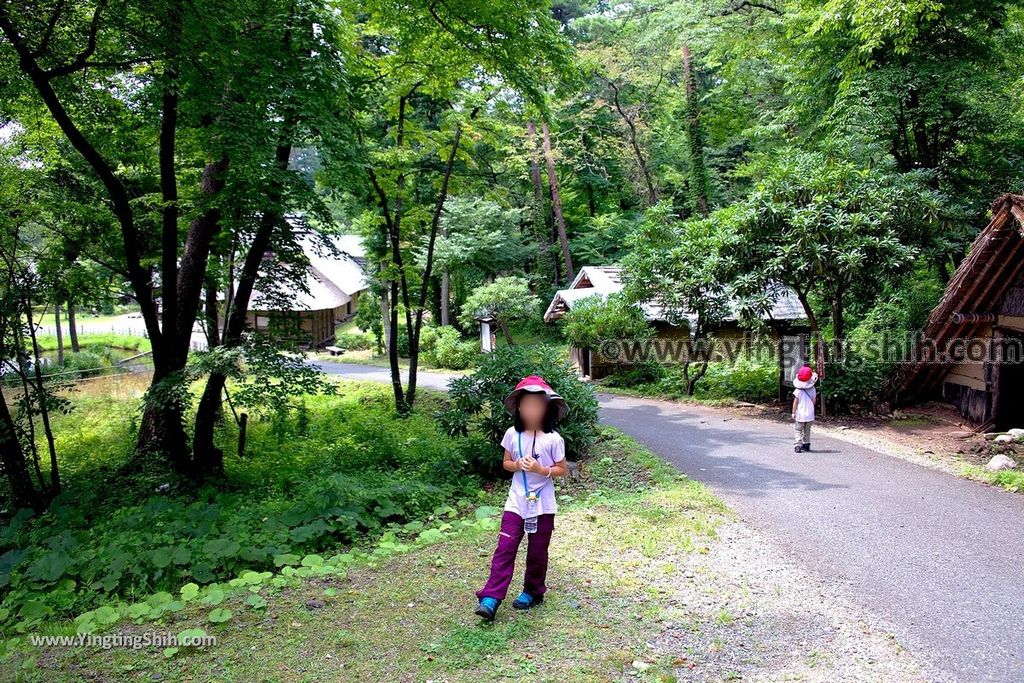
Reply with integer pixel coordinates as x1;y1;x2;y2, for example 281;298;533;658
439;346;597;475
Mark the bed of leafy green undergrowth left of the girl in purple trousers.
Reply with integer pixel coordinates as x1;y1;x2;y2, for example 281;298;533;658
0;385;479;631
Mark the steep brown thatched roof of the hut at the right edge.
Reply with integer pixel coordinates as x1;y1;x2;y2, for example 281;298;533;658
886;195;1024;400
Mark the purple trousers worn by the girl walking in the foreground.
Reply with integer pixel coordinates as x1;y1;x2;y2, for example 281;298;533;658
476;510;555;600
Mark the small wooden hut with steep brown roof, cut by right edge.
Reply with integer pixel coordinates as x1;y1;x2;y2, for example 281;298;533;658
887;195;1024;428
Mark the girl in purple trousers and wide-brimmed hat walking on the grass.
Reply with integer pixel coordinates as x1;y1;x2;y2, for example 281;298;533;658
476;375;568;621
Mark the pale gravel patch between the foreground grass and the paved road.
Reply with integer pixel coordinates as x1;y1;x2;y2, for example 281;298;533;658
645;521;941;683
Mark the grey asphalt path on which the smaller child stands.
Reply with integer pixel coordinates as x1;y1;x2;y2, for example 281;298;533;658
323;364;1024;683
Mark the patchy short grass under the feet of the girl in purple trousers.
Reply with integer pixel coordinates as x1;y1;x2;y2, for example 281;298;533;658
6;428;731;682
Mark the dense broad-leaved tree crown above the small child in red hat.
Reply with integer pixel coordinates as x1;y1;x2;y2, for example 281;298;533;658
715;150;940;337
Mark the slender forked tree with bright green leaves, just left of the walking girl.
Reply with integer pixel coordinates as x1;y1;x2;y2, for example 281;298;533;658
342;0;564;413
